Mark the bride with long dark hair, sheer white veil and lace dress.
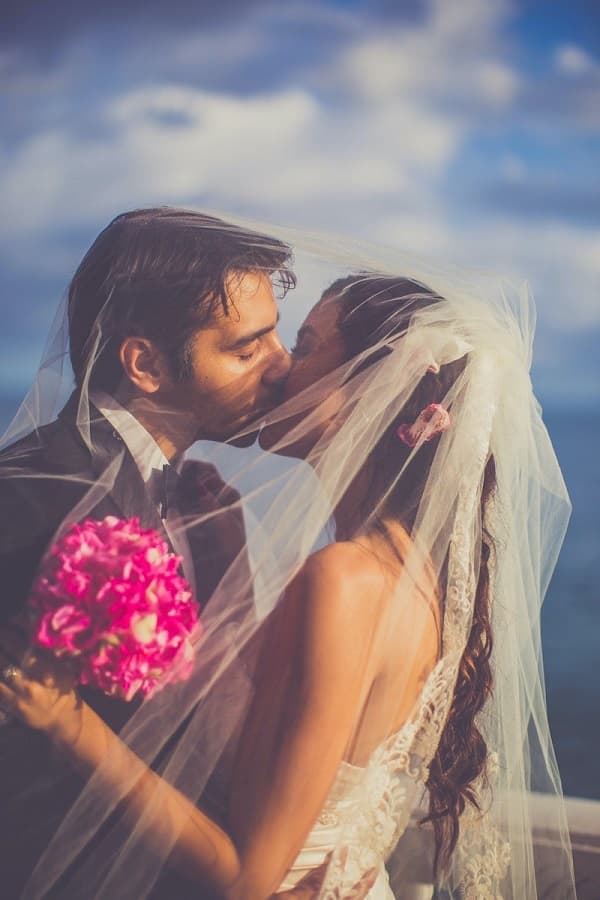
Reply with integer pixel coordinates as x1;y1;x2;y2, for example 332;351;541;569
0;229;575;900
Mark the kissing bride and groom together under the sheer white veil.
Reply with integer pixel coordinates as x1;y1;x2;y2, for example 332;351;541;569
0;208;575;900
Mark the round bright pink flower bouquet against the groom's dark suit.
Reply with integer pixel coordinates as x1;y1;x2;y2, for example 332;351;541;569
30;516;200;700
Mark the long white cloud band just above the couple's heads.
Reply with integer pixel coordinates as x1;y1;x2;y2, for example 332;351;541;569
0;74;462;240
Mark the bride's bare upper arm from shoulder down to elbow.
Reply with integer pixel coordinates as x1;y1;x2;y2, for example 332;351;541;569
231;544;382;897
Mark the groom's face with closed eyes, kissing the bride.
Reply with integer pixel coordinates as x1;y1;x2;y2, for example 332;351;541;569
161;272;290;445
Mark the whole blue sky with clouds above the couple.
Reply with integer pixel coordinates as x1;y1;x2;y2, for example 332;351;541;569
0;0;600;407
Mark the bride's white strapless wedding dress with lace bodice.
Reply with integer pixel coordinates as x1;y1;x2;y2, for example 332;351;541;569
279;660;510;900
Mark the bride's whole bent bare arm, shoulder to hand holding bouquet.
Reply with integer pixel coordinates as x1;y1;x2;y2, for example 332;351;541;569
0;545;382;900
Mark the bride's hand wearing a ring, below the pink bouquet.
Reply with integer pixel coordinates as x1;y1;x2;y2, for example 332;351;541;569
0;629;82;744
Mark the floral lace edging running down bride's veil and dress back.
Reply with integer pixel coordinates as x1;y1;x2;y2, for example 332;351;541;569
320;354;510;900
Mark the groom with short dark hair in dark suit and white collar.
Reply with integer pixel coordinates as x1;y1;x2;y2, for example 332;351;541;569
0;208;294;900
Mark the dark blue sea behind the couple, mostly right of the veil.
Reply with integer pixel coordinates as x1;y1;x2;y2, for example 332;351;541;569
0;394;600;799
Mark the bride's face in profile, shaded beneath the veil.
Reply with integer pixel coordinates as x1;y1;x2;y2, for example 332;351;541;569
259;294;347;459
